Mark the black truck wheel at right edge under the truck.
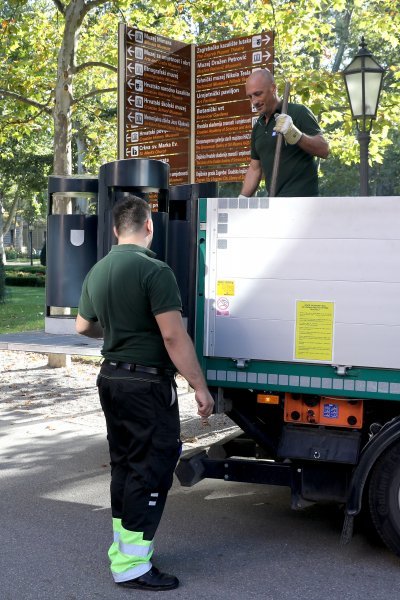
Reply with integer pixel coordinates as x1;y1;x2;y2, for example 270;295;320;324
369;444;400;556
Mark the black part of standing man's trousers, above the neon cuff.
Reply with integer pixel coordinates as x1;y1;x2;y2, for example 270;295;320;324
97;364;181;540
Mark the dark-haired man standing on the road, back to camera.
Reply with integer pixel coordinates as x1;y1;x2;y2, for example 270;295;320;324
76;195;214;591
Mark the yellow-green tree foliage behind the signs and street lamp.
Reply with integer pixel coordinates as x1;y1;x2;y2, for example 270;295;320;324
0;0;400;225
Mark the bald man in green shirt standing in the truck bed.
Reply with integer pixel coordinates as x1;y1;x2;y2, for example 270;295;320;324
241;69;329;197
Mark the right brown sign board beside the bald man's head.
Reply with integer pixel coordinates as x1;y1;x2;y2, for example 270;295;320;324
195;33;273;183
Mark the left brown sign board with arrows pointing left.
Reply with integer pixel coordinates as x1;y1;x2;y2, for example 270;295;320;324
118;24;191;185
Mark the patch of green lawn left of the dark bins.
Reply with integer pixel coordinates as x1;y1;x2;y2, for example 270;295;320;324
0;286;46;333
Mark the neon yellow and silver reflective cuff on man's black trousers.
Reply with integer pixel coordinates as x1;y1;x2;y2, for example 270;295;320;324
108;518;153;583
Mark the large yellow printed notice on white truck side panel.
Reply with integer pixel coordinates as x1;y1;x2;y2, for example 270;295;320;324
294;300;334;362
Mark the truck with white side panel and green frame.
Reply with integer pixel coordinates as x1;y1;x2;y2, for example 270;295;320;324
177;196;400;555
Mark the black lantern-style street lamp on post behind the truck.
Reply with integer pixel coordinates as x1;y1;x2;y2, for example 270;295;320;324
343;37;385;196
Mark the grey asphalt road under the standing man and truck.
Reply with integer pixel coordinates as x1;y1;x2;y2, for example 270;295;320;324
0;410;400;600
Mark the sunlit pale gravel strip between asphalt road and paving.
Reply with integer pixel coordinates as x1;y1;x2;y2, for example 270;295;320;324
0;351;236;451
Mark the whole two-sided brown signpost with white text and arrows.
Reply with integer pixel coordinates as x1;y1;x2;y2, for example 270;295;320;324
118;24;273;185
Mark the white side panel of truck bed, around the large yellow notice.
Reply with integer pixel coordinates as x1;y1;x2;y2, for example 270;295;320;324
204;197;400;368
